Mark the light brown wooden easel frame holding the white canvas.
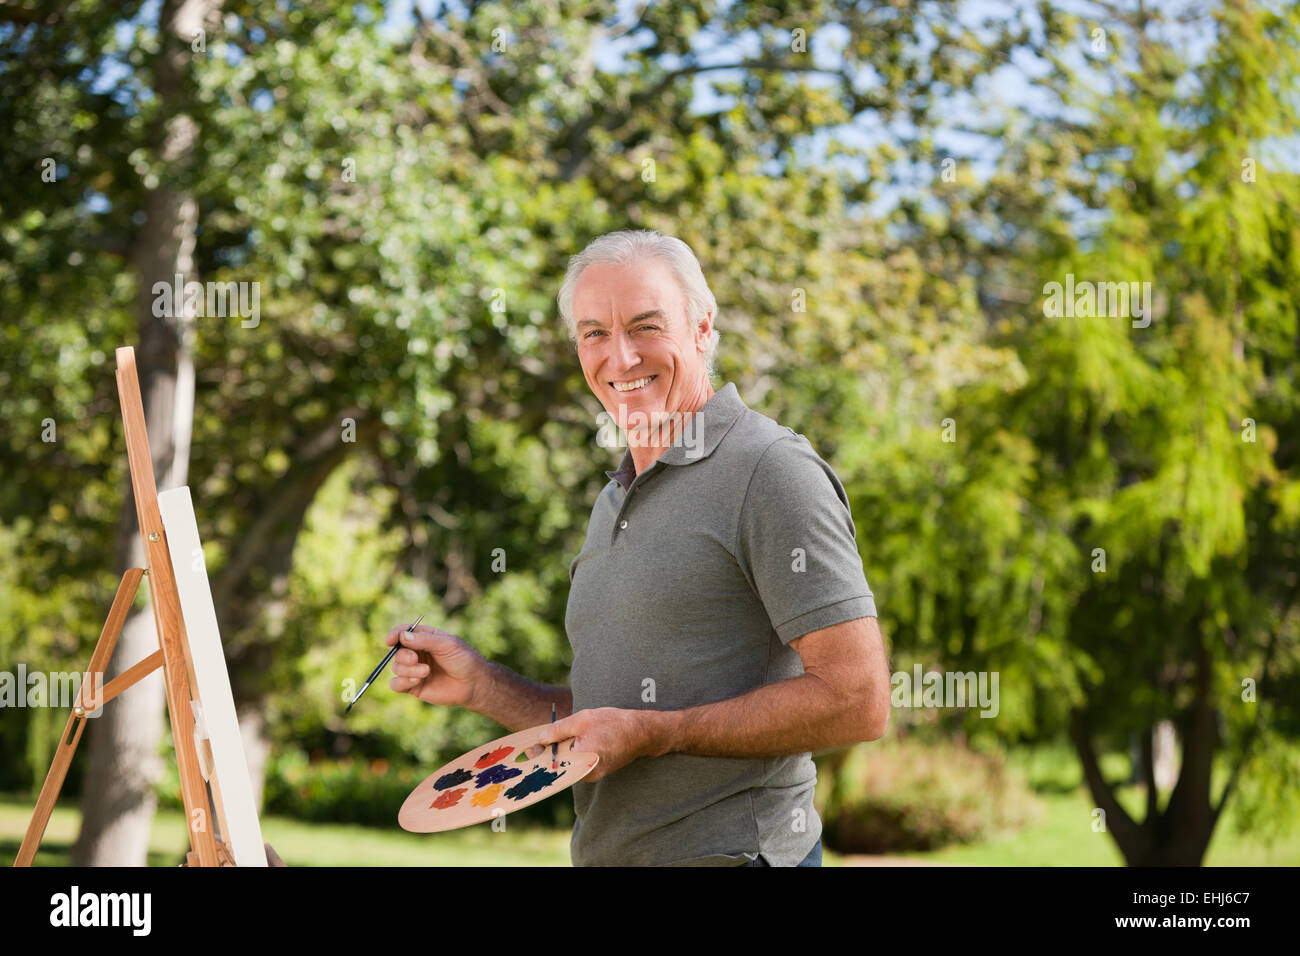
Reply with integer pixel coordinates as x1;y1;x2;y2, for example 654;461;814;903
14;347;235;866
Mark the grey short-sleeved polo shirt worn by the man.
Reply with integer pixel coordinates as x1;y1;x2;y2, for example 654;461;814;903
564;384;876;866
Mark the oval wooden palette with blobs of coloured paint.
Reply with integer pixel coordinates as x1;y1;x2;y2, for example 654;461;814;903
398;723;601;834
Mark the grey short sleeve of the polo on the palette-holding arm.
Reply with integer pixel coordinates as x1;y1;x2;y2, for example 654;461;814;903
736;432;876;644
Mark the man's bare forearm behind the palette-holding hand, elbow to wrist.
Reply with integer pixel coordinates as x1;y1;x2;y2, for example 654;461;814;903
647;674;870;757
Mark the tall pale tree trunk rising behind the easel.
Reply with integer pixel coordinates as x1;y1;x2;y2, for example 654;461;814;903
72;0;217;866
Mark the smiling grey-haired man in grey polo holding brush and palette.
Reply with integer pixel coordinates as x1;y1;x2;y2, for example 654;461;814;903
387;232;889;866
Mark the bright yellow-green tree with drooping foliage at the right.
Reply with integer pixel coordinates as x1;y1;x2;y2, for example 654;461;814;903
853;3;1300;865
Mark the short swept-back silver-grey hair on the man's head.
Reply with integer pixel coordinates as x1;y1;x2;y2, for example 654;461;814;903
558;229;719;378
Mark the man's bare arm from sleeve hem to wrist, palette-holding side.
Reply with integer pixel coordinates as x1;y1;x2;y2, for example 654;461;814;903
644;618;889;757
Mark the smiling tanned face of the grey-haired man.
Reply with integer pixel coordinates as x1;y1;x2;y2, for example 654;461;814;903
573;259;712;425
